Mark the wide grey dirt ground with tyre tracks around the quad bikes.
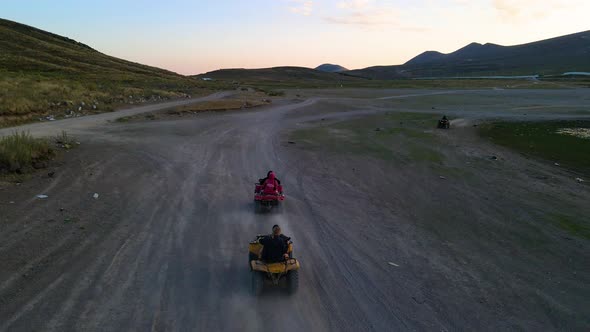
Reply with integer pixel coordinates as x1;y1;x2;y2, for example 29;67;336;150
0;91;590;331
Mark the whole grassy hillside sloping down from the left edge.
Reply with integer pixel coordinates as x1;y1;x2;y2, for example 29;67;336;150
0;19;224;127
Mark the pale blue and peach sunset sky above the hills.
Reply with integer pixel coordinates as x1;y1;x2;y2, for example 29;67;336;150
0;0;590;74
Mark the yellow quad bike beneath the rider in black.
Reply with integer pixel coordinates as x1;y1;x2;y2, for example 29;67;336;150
248;235;300;295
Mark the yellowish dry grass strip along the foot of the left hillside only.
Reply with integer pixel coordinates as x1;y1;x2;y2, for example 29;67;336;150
0;75;220;127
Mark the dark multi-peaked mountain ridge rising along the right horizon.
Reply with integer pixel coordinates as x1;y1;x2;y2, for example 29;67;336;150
346;31;590;79
